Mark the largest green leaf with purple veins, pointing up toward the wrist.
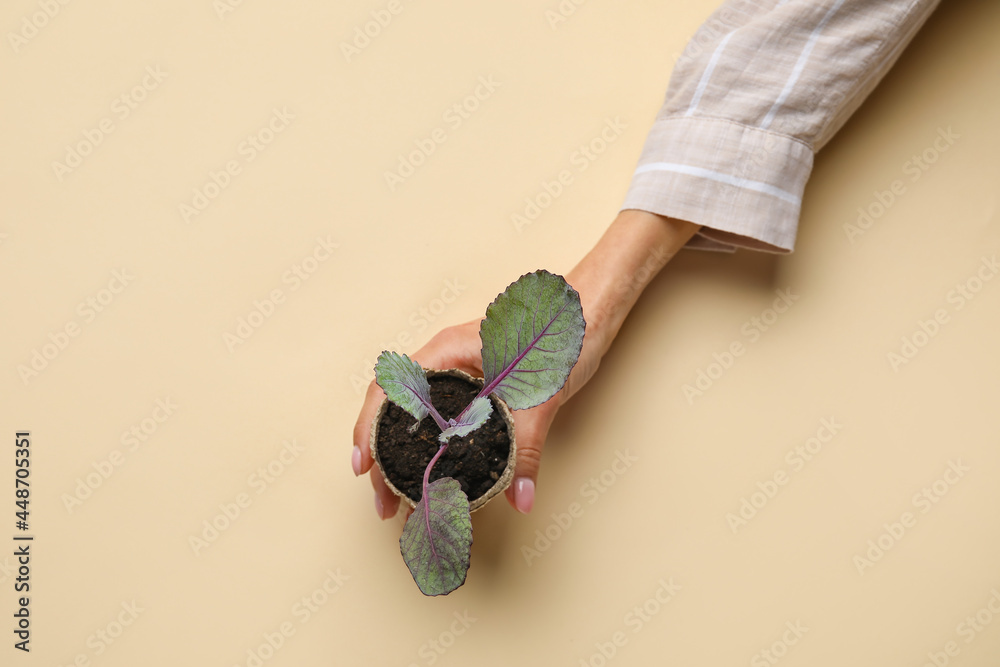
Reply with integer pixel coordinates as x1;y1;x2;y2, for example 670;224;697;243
479;270;586;410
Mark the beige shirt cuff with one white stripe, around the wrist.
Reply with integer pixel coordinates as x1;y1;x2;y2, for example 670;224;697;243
622;116;813;253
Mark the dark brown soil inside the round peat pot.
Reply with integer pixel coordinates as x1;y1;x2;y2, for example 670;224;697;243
377;375;510;502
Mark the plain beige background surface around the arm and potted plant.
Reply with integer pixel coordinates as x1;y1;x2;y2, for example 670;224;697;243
0;0;1000;667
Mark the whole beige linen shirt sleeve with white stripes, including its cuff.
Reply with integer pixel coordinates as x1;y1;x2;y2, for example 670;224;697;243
622;0;938;253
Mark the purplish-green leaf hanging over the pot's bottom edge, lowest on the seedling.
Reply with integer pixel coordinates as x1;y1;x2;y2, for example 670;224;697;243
399;477;472;595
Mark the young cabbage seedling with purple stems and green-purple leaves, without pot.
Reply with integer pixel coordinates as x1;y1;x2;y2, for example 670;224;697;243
375;270;586;595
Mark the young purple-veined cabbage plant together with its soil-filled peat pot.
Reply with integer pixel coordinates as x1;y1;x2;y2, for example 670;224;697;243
371;270;586;595
